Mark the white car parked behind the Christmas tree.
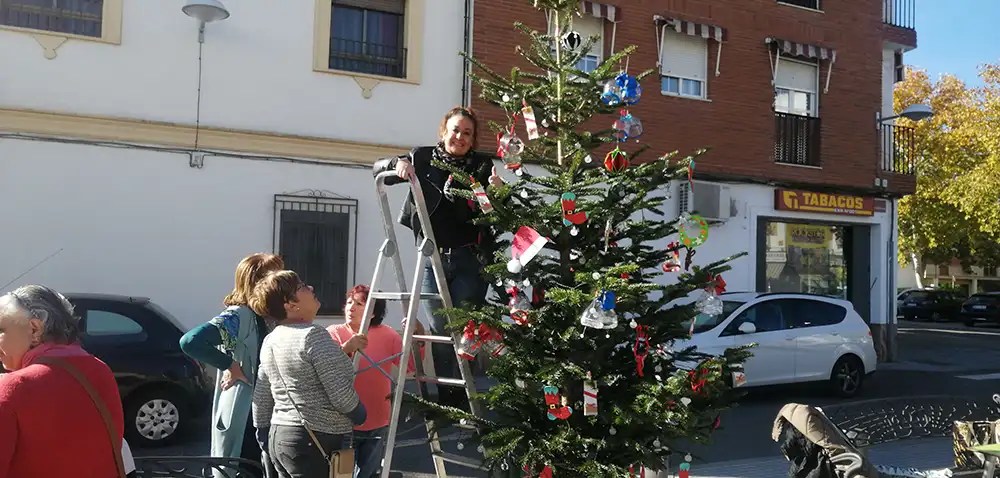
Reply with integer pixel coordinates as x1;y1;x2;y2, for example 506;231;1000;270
671;292;878;397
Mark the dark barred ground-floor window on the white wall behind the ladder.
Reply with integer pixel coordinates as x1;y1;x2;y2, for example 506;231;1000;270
274;191;358;315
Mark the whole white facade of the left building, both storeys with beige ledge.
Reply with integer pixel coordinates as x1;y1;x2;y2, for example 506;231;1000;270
0;0;465;327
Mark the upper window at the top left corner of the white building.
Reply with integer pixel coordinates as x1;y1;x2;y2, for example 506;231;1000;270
0;0;122;43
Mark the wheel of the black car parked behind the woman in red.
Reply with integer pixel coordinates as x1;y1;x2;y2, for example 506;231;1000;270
125;388;190;448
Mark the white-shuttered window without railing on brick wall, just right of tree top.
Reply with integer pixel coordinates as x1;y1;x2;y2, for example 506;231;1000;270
660;30;708;98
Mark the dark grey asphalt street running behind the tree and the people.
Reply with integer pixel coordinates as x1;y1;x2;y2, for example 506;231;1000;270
135;322;1000;478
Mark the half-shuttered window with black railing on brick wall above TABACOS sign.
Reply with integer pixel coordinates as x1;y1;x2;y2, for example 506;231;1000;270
774;59;820;166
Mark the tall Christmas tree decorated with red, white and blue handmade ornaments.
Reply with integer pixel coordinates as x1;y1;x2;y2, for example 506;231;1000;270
408;0;749;477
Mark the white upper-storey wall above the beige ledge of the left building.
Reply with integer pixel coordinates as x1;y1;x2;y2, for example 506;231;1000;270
0;0;464;147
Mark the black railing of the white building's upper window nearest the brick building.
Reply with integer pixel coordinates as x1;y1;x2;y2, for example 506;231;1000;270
330;38;406;78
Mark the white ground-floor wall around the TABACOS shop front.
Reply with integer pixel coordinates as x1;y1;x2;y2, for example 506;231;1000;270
662;184;895;324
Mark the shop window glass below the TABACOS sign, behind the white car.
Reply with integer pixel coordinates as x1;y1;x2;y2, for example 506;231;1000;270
765;222;848;299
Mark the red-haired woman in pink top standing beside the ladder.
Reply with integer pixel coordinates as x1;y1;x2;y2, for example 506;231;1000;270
327;285;424;478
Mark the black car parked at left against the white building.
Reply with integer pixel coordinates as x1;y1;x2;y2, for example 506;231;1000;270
65;294;214;448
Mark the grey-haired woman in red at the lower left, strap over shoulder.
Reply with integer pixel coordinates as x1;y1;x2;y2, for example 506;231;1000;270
0;285;125;478
